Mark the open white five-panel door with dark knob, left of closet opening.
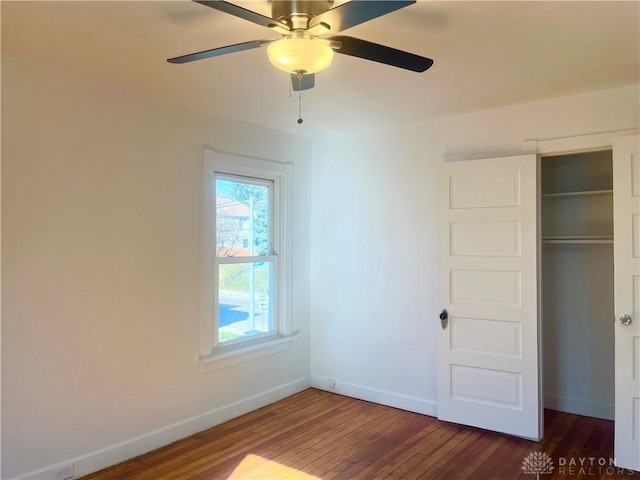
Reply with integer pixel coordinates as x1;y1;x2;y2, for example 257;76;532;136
435;155;542;439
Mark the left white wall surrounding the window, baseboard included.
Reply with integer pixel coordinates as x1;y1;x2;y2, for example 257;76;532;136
1;55;311;479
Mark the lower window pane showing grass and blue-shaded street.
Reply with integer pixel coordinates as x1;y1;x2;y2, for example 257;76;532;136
218;262;274;343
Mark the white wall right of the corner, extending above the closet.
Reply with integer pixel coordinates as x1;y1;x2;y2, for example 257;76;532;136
311;86;640;414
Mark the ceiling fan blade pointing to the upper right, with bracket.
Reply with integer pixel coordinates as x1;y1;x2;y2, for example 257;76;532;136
310;0;416;33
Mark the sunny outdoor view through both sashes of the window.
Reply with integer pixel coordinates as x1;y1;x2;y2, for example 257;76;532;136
215;174;277;344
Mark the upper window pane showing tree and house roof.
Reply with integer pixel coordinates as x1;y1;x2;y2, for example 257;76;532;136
216;178;271;257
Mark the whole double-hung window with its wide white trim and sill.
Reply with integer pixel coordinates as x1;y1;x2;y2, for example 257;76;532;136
200;149;293;371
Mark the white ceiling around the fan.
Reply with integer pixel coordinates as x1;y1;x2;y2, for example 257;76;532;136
0;0;640;136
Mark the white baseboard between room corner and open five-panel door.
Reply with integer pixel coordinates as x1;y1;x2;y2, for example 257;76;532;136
311;375;438;417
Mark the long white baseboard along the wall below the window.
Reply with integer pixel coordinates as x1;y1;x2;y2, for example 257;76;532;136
14;377;311;480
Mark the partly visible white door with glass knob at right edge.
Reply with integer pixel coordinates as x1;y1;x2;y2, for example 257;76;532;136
613;136;640;470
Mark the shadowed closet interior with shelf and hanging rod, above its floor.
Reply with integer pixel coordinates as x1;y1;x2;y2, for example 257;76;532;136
541;150;614;419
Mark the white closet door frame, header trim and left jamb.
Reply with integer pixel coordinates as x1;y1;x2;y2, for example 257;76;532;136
522;128;640;442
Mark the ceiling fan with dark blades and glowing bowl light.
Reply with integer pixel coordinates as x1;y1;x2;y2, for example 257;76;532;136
167;0;433;91
